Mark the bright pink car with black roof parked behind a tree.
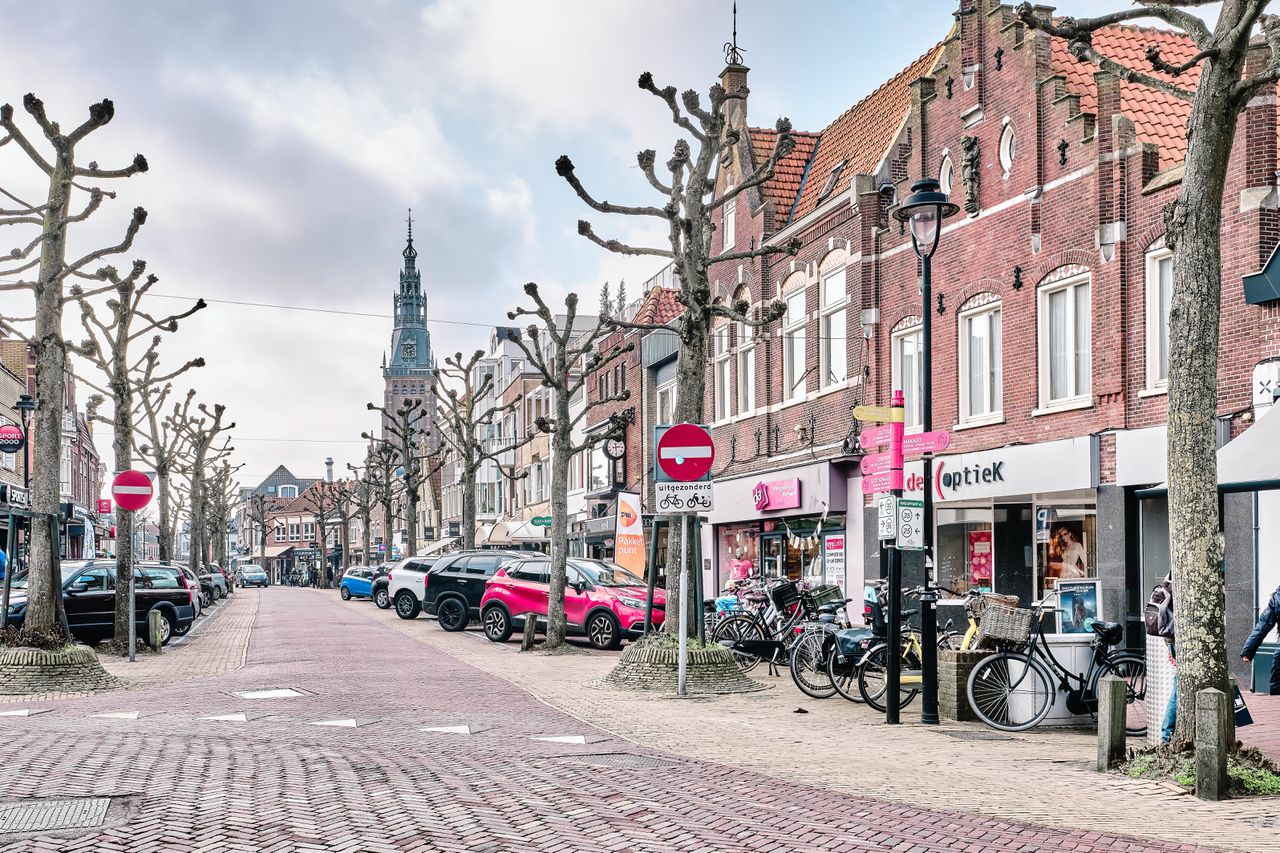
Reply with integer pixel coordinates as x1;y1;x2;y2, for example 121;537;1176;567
480;555;667;648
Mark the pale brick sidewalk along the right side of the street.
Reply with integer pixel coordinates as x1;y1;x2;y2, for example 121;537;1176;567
358;591;1280;853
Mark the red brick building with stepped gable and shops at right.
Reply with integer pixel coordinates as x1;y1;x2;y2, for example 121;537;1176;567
686;0;1280;691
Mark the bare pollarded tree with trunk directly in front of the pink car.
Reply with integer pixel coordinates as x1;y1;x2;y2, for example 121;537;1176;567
507;282;635;649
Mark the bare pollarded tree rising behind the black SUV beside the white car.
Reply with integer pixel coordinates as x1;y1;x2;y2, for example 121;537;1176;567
435;350;536;548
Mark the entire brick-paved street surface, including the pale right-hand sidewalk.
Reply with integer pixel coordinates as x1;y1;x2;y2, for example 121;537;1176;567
0;588;1280;853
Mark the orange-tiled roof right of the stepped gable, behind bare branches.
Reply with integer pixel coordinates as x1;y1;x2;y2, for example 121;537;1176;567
1052;26;1201;168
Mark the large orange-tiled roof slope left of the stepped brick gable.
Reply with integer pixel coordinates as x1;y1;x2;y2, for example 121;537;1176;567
794;44;942;219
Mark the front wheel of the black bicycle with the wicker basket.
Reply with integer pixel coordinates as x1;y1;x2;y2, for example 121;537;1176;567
968;652;1056;731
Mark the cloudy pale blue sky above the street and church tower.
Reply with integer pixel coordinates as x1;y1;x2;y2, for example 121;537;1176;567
0;0;1141;485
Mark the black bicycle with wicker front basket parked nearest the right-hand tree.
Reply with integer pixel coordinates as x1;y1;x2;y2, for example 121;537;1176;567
968;593;1147;736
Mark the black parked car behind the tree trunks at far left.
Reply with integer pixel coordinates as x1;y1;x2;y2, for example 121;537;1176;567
9;560;196;644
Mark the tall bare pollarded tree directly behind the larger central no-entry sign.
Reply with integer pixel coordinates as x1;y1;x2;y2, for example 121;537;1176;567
556;72;800;630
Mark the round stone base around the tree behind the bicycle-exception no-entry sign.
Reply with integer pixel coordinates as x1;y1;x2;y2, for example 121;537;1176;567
600;639;765;695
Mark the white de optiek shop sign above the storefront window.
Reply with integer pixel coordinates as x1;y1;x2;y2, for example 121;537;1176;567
904;435;1097;503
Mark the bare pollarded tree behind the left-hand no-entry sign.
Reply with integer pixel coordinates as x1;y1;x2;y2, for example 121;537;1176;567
79;261;205;647
